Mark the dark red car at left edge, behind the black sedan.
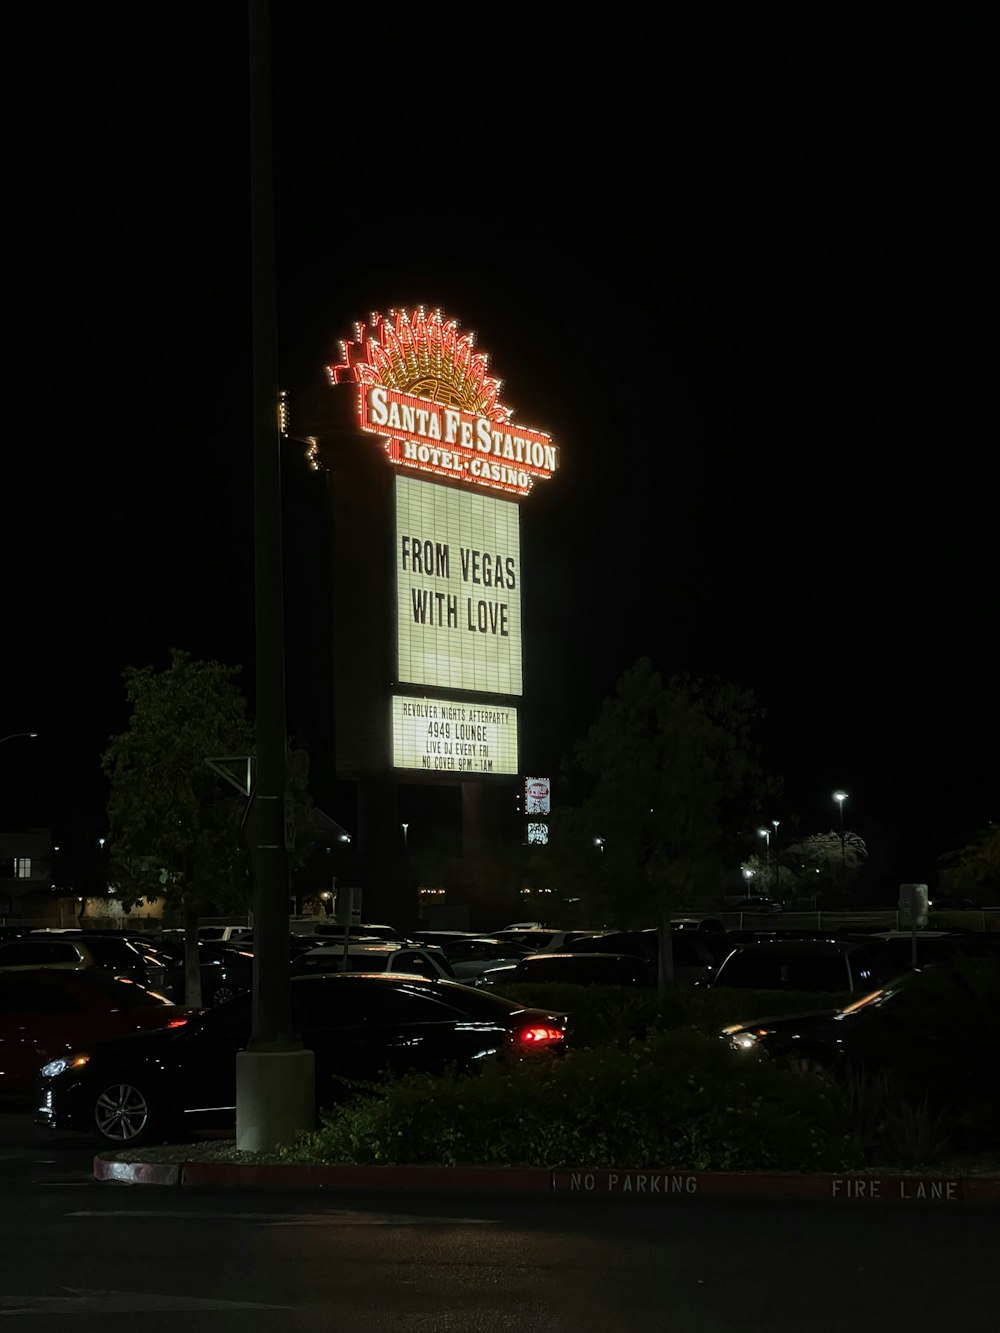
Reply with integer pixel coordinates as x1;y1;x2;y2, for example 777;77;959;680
0;968;197;1096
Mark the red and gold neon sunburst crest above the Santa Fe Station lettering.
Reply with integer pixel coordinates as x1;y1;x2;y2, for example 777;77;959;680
327;305;512;423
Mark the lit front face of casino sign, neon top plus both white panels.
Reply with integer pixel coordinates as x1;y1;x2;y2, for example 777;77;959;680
328;309;559;777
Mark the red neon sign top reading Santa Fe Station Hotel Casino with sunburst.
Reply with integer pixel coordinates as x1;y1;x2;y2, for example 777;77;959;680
327;308;559;496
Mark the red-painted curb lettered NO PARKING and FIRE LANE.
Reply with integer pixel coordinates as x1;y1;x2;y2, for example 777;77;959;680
93;1156;1000;1206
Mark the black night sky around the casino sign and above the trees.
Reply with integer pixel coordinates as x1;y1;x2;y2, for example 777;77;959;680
0;4;1000;888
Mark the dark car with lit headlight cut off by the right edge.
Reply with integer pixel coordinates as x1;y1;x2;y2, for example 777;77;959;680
720;958;1000;1125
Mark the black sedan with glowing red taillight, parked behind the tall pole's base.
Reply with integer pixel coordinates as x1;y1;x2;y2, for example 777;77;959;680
36;973;569;1148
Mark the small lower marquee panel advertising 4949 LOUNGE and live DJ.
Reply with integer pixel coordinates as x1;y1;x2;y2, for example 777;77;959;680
392;694;517;774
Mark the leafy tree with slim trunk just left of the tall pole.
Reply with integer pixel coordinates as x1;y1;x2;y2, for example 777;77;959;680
101;649;253;1005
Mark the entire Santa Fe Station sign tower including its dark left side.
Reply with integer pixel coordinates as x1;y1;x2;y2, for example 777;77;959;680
312;307;559;782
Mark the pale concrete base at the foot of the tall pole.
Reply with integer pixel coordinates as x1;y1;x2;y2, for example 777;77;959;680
236;1050;316;1153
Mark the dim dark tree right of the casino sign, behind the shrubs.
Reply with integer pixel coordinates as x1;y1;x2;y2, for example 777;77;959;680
536;657;776;981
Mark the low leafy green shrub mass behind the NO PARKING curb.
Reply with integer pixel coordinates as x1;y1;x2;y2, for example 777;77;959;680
283;1028;863;1170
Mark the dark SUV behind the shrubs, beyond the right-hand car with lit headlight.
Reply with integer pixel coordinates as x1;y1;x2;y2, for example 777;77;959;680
708;938;899;994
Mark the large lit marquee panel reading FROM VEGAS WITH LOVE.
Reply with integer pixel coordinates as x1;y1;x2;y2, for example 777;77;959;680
396;476;521;698
